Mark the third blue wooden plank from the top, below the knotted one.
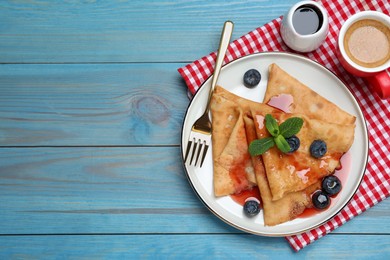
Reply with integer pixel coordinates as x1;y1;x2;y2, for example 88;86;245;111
0;147;390;234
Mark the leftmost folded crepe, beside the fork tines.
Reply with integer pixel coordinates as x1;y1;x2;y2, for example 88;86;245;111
210;86;275;197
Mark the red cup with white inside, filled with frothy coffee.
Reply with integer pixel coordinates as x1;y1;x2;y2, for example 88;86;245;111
337;11;390;99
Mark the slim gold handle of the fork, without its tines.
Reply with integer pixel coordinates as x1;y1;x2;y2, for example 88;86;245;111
206;21;234;113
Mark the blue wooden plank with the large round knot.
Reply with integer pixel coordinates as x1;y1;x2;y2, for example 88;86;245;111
0;63;189;146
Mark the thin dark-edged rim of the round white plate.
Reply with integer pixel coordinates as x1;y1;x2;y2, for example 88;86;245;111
180;51;370;237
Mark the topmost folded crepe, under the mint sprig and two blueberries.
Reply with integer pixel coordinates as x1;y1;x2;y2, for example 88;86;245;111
252;109;354;200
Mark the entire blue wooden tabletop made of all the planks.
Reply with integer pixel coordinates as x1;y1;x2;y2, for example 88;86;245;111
0;0;390;259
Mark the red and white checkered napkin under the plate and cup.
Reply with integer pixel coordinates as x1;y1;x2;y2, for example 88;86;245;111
178;0;390;251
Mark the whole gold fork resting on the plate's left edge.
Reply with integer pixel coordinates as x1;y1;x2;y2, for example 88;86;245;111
184;21;234;167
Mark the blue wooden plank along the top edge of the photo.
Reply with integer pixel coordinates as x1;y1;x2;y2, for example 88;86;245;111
0;0;297;63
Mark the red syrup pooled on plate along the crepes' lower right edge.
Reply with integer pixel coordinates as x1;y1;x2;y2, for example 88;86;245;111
298;151;351;218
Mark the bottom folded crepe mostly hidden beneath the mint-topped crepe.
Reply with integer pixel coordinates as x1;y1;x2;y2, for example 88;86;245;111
244;114;321;226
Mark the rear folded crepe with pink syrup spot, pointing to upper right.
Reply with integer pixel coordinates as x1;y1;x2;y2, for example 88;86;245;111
263;63;356;124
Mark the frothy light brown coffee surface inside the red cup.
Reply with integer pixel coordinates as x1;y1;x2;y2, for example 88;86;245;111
344;19;390;68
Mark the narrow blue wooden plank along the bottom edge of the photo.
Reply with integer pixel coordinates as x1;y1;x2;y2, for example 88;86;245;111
0;234;390;259
